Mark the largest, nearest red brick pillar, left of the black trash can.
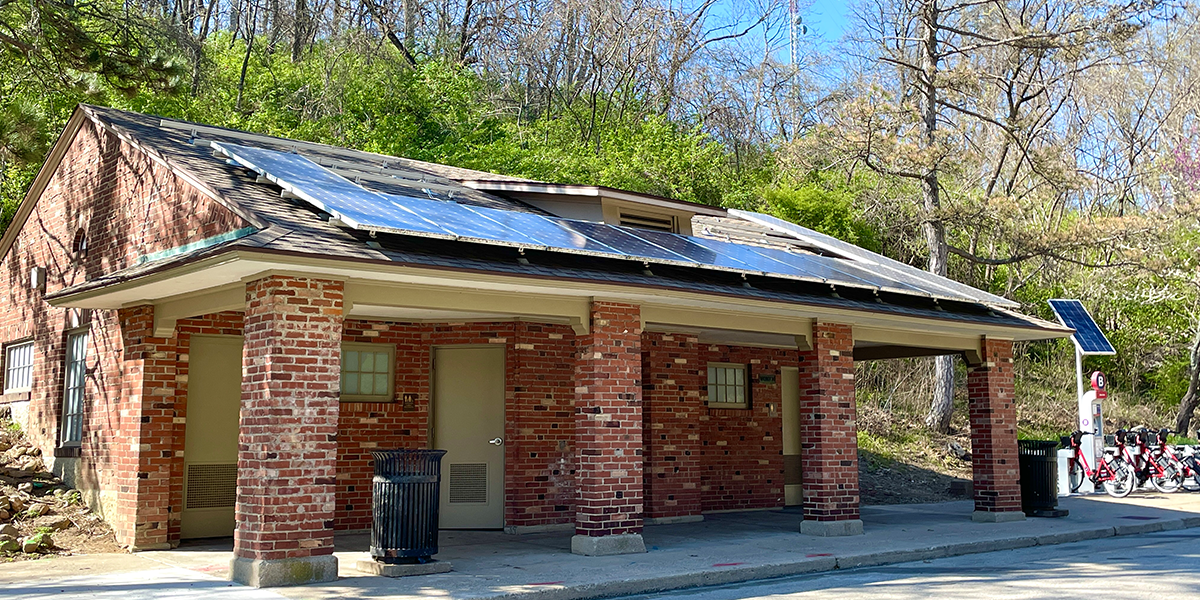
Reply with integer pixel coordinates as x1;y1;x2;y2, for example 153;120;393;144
233;276;343;587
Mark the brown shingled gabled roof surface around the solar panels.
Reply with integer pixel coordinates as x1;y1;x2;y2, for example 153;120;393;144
14;106;1062;335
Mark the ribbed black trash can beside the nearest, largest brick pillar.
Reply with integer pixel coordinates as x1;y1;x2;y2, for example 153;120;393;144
371;450;446;564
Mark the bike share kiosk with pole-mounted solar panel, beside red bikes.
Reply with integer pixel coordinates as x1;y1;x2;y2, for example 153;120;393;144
1049;300;1117;496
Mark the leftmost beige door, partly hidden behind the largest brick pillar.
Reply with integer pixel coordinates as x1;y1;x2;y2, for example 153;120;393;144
180;336;241;539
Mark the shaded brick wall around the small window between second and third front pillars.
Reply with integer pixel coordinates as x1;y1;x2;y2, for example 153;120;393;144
700;346;798;511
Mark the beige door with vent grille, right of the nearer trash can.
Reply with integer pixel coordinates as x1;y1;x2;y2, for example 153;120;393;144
433;347;504;529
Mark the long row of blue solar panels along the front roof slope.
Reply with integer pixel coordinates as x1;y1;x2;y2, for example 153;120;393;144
211;142;996;304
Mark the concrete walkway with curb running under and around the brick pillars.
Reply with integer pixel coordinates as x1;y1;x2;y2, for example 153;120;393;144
0;492;1200;600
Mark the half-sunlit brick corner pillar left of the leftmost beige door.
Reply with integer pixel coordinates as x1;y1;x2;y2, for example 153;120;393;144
115;305;175;551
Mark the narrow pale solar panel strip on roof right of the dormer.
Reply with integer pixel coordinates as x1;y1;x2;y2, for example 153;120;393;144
730;209;1020;307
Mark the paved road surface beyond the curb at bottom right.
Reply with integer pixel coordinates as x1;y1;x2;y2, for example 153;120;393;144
623;529;1200;600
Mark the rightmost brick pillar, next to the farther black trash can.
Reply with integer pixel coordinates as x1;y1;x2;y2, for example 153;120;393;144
967;338;1025;522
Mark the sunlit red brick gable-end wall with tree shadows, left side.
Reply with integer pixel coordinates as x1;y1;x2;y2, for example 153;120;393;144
0;121;246;546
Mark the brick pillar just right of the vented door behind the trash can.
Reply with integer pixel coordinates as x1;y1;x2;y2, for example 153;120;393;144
571;301;646;556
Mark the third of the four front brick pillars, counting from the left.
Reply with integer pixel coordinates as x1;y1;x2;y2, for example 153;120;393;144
800;322;863;535
